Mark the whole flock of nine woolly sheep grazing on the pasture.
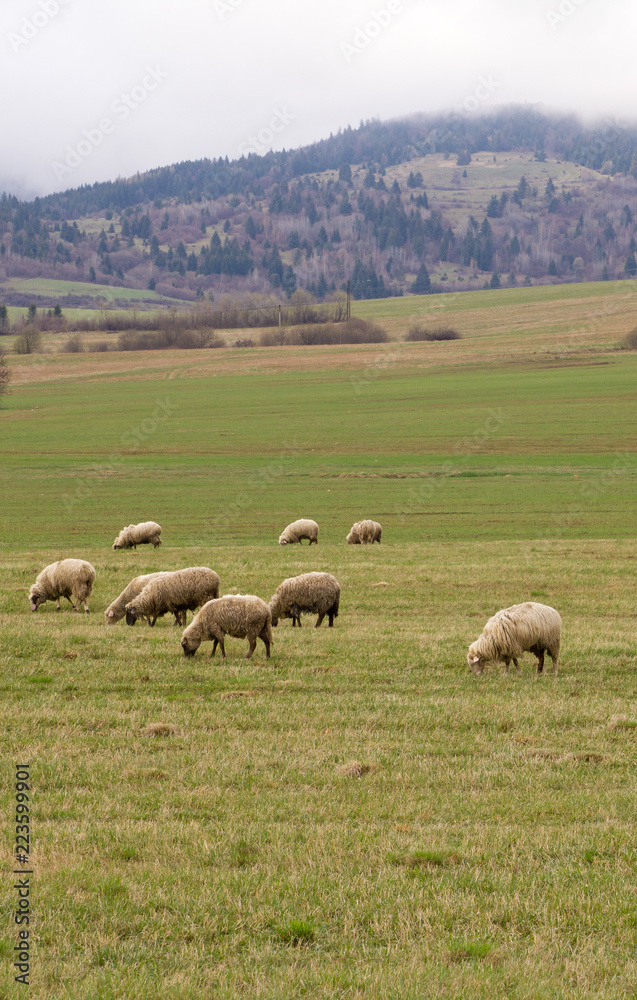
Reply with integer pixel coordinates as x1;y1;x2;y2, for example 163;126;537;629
29;518;562;674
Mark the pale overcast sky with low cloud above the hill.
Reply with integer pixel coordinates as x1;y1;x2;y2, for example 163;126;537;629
0;0;637;197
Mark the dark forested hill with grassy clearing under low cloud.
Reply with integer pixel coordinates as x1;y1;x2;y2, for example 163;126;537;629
0;107;637;302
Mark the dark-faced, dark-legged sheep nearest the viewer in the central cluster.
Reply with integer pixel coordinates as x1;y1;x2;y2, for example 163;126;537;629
181;594;272;660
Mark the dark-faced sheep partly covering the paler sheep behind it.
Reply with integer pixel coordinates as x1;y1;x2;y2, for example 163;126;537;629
126;566;219;628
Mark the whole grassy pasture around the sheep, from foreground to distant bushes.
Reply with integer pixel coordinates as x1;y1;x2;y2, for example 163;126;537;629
0;286;637;1000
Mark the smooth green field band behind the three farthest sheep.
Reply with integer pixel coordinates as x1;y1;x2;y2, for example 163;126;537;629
0;347;637;547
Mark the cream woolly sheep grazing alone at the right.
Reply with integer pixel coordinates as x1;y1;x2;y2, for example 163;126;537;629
467;601;562;674
